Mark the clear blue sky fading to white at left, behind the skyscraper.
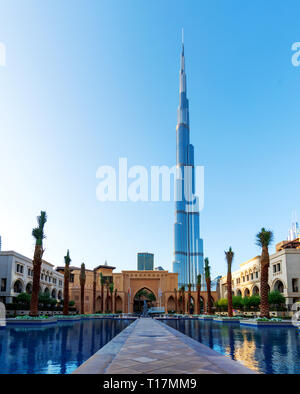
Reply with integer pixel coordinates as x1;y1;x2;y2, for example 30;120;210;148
0;0;300;275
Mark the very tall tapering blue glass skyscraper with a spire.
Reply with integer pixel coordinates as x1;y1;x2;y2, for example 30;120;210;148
173;38;203;288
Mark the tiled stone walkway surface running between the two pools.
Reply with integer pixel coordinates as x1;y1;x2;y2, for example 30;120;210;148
103;318;254;374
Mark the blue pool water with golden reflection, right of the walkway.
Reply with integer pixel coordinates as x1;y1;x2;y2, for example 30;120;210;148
164;320;300;374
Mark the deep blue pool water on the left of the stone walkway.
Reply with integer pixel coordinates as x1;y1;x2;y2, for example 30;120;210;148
0;319;131;374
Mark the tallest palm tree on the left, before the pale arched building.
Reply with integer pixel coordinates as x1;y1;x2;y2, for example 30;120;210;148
30;211;47;316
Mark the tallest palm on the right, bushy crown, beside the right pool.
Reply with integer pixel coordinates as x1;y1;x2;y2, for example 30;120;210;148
256;228;274;318
